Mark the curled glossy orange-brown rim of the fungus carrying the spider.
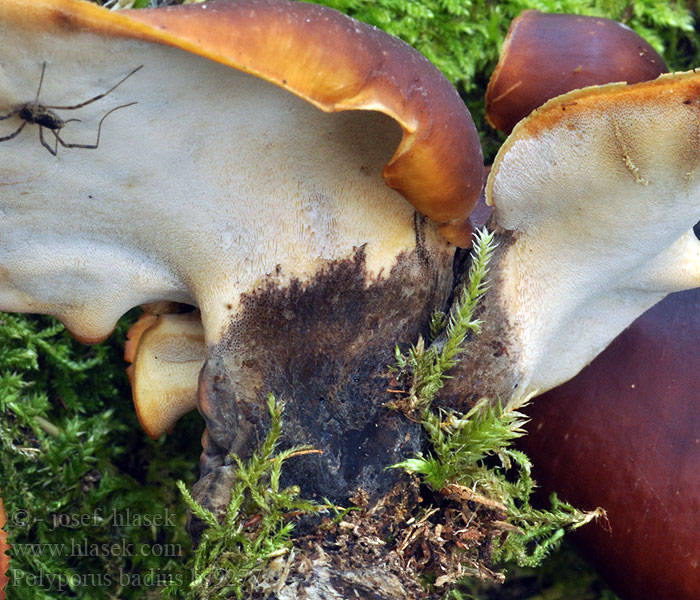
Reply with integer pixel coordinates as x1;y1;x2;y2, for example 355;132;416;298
23;0;482;247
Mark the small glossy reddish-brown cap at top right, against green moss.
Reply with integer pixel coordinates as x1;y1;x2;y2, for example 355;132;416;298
486;10;668;133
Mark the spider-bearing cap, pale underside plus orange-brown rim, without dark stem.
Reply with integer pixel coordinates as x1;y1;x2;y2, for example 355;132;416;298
0;0;483;342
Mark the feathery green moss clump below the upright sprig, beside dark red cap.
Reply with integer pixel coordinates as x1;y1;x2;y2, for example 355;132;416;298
395;400;605;567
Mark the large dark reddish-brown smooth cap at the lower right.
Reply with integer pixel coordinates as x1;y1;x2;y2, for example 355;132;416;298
521;289;700;600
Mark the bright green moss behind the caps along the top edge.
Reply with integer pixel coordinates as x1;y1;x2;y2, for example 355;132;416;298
318;0;698;84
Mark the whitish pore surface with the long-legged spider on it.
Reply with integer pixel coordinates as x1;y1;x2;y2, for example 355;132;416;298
0;30;445;341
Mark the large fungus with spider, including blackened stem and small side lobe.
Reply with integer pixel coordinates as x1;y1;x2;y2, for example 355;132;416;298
0;0;483;544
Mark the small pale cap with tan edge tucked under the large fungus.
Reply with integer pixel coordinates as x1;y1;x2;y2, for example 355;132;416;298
124;311;206;439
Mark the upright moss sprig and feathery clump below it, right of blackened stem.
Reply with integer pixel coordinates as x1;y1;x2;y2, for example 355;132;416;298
392;230;605;582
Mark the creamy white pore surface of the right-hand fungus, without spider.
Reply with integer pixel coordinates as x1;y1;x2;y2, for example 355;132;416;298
490;91;700;395
